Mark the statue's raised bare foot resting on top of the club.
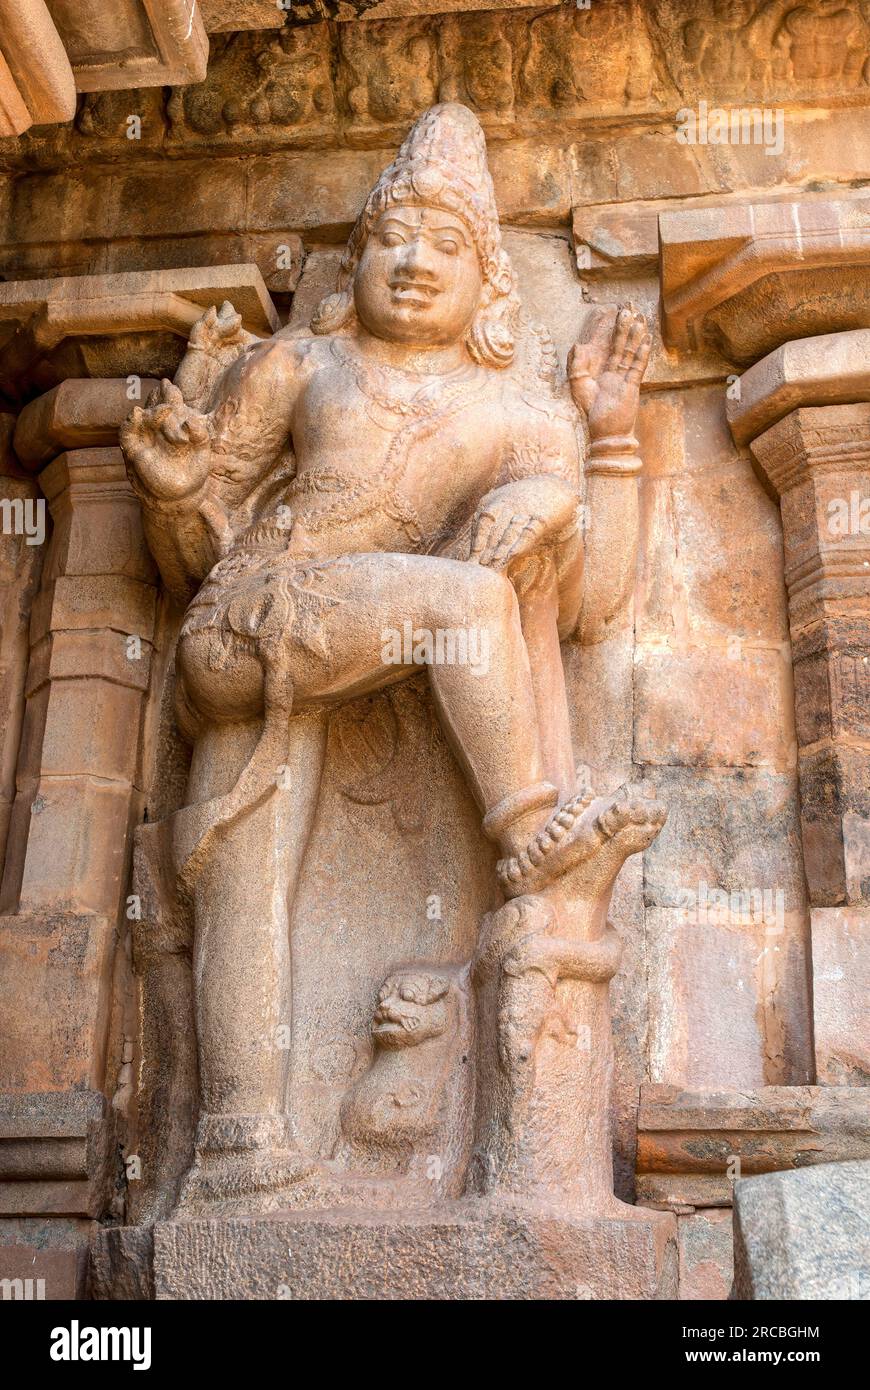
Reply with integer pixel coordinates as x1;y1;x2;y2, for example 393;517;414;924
498;785;667;898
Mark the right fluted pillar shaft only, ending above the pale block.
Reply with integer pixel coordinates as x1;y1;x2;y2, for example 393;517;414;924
752;402;870;908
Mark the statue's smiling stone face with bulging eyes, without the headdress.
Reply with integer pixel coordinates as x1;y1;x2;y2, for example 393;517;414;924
353;206;484;348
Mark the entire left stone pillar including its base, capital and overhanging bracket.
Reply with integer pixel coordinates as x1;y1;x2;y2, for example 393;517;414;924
0;265;277;1298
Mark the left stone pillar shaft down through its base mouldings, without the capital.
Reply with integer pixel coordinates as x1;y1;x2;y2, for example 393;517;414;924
0;414;156;1298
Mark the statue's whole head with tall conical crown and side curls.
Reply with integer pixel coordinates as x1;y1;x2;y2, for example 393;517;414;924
311;101;520;367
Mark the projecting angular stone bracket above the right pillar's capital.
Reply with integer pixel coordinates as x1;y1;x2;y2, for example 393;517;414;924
659;196;870;363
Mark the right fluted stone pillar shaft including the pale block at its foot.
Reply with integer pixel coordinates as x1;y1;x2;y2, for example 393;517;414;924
752;403;870;1084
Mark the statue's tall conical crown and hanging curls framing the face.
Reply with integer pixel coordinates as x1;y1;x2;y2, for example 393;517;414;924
311;101;518;366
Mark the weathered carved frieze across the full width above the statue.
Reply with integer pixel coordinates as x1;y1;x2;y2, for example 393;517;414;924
0;0;870;164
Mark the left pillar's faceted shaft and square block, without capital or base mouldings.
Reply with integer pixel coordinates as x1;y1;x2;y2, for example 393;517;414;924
0;449;154;1091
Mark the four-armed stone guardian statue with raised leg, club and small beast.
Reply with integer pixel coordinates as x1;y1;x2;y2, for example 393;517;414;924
121;104;664;1256
